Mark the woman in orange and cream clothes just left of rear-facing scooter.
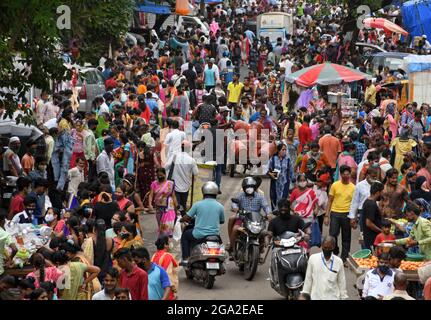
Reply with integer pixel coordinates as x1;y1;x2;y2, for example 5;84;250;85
151;235;179;300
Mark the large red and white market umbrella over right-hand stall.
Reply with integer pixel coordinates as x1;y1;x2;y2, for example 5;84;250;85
286;62;371;87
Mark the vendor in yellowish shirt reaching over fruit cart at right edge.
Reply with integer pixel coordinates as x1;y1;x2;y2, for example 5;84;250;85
385;204;431;260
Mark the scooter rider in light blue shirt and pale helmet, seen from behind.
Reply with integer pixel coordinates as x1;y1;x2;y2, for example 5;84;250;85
180;181;224;266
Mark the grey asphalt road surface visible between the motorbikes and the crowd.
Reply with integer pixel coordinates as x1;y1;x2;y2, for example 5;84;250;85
141;175;359;300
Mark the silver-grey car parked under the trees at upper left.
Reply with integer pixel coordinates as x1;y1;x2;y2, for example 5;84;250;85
76;68;106;112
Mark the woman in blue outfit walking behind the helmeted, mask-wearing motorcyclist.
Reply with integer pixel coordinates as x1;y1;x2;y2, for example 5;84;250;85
268;143;294;210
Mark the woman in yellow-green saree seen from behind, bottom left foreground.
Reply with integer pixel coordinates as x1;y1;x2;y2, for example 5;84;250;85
52;243;101;300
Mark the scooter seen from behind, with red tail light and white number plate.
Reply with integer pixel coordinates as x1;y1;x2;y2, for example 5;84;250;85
184;222;226;289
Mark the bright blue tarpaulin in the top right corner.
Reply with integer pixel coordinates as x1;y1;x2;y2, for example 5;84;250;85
401;0;431;39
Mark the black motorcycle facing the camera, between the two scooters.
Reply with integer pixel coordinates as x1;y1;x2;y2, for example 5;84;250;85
231;198;266;281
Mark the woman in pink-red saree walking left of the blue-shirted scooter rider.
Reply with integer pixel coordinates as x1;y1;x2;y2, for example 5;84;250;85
148;168;178;235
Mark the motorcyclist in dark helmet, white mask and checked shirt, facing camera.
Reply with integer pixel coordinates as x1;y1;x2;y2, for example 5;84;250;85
227;177;271;259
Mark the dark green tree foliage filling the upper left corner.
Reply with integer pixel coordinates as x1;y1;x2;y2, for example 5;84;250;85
0;0;135;124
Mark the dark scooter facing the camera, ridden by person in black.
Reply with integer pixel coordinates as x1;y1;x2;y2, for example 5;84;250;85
268;223;311;300
